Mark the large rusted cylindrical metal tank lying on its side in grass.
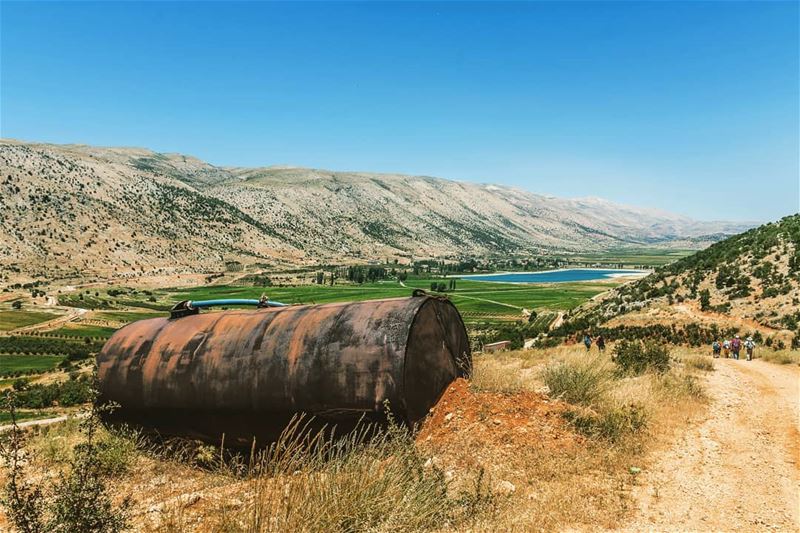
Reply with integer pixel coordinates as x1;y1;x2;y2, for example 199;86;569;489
97;296;471;444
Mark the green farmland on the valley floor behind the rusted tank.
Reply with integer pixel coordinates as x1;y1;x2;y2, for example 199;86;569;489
0;275;632;376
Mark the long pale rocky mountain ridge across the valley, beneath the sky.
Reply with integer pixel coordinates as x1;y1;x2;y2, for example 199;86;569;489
0;140;743;279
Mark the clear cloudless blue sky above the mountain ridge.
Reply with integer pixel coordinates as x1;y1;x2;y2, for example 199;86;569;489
0;1;800;220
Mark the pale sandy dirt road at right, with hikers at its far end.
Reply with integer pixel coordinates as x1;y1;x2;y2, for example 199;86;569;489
627;359;800;531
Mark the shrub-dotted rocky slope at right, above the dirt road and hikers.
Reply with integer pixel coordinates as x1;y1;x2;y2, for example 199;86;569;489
571;214;800;335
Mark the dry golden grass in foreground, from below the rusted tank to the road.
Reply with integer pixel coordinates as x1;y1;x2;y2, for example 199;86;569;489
0;347;703;533
